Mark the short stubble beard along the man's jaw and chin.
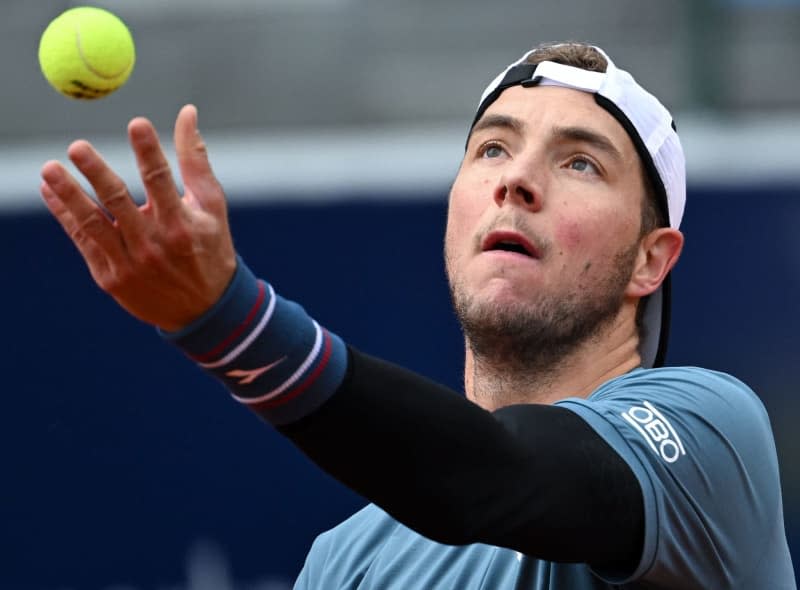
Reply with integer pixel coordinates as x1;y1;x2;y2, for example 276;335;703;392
448;244;637;382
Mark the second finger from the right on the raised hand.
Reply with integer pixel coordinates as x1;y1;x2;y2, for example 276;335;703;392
128;117;182;220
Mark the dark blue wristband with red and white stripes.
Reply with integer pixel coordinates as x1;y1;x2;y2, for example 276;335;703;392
159;259;347;425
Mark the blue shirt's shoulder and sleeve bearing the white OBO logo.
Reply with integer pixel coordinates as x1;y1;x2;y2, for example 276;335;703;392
559;367;787;588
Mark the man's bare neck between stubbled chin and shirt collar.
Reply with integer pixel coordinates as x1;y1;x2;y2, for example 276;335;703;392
464;306;641;411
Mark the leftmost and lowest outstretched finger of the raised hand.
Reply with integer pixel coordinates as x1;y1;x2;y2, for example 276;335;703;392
42;160;126;260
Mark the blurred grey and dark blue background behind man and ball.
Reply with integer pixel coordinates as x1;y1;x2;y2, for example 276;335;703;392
0;0;800;590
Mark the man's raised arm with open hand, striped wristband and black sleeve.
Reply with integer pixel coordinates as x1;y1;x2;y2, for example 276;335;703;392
41;107;642;564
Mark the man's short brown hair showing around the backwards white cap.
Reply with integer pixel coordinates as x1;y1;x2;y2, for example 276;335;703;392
525;41;669;330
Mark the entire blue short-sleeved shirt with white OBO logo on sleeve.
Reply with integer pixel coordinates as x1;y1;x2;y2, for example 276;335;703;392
295;367;797;590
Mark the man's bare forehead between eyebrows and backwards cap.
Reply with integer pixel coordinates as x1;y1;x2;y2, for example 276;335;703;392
479;85;638;161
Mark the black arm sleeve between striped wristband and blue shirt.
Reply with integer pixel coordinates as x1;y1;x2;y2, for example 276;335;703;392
280;349;644;569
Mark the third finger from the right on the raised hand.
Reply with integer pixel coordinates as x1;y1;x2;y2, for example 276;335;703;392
67;140;144;245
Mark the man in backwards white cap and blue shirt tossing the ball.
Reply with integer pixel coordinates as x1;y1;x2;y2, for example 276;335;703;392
41;43;795;590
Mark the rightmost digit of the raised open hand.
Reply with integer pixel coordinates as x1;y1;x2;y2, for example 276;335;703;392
174;104;225;214
